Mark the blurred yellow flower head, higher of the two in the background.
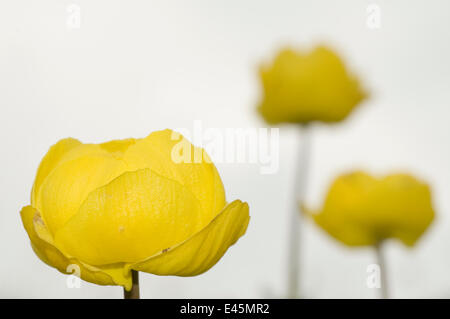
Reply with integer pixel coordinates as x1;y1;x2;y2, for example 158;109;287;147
258;46;366;124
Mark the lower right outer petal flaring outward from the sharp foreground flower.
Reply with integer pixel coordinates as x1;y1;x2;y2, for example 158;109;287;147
129;200;250;276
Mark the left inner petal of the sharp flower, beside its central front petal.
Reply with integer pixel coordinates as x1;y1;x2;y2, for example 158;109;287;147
36;155;125;235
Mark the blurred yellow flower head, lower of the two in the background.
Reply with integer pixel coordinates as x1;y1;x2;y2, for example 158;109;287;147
306;172;434;246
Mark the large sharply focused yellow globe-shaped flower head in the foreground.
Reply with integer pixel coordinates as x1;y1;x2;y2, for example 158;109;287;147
21;130;250;290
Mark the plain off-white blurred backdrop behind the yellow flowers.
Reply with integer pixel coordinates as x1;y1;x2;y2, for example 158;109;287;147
0;0;450;298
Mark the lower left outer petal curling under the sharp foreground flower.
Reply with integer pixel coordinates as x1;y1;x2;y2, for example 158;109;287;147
20;206;131;289
